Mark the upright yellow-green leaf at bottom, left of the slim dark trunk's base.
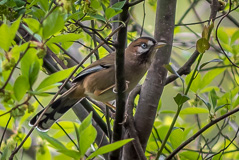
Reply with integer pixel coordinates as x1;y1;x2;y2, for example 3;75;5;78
80;125;97;156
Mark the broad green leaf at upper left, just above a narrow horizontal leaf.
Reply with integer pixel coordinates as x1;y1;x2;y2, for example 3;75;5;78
43;10;64;39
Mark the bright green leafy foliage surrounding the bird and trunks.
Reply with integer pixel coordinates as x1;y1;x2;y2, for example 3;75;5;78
0;0;239;160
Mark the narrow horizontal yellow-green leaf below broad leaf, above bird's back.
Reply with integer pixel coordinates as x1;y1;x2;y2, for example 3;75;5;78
46;33;81;44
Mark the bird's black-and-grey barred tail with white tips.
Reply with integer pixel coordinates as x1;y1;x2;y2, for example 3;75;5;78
29;94;79;132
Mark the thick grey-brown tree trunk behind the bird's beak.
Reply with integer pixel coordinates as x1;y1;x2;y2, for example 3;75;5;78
123;0;176;160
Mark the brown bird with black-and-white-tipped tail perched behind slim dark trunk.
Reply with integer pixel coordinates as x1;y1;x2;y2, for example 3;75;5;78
29;37;166;132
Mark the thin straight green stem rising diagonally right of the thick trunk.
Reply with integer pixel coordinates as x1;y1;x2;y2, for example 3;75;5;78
156;54;203;159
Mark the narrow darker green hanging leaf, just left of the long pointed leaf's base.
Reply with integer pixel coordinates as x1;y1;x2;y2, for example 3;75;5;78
29;58;40;86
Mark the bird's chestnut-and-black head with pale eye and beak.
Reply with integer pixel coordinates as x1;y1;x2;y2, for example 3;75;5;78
126;37;166;63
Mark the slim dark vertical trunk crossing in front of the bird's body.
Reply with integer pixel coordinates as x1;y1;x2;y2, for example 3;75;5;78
110;2;128;160
